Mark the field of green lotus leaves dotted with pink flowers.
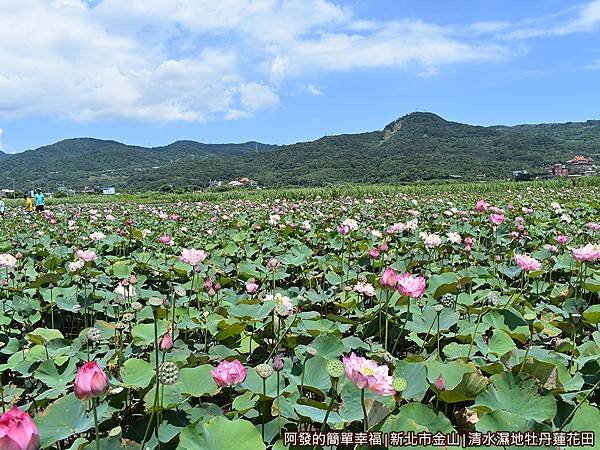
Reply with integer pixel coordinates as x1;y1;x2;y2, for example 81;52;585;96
0;185;600;450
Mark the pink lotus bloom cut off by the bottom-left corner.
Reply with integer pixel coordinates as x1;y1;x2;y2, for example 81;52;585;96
0;406;40;450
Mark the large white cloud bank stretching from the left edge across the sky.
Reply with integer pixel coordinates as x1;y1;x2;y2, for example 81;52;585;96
0;0;600;122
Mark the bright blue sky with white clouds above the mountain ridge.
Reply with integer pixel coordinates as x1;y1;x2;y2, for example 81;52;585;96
0;0;600;152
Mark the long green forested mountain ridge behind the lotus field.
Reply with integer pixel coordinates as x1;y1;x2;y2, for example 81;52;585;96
0;112;600;190
